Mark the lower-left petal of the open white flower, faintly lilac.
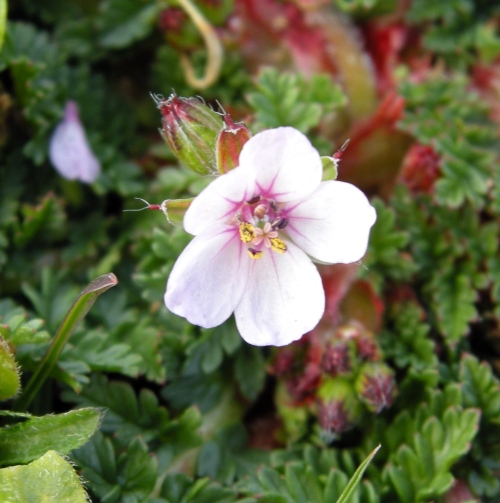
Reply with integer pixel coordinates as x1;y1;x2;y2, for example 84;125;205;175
165;225;249;328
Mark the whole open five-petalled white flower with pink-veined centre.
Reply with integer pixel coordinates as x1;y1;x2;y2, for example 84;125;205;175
165;127;376;346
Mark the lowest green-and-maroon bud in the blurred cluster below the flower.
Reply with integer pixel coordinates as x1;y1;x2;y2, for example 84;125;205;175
317;378;361;433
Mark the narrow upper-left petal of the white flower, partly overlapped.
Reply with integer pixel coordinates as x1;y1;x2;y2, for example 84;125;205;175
184;168;255;236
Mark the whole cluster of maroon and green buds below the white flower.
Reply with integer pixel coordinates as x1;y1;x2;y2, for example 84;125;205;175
271;322;396;438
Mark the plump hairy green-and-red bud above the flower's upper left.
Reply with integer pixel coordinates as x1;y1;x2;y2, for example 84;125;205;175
154;95;224;175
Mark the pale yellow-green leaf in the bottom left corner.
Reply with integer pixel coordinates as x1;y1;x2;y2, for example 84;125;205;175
0;451;87;503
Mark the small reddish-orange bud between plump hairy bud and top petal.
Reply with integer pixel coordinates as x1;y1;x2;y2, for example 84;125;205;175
217;114;251;174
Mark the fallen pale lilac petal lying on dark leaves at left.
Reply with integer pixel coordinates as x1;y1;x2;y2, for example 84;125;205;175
49;101;101;183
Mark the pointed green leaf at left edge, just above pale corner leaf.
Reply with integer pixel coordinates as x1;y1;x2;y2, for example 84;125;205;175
0;409;101;466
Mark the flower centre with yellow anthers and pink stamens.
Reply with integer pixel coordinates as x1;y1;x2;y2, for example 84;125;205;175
236;196;288;259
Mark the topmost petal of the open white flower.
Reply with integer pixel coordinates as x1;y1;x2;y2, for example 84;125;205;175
240;127;323;202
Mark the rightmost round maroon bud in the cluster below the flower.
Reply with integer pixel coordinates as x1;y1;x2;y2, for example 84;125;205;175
355;363;396;414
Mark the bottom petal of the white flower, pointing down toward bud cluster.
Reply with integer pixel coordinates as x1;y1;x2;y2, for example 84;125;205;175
235;243;325;346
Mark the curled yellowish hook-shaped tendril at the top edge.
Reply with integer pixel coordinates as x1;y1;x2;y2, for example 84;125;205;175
177;0;223;89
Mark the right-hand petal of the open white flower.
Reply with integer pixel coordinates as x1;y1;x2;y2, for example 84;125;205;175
282;181;377;264
